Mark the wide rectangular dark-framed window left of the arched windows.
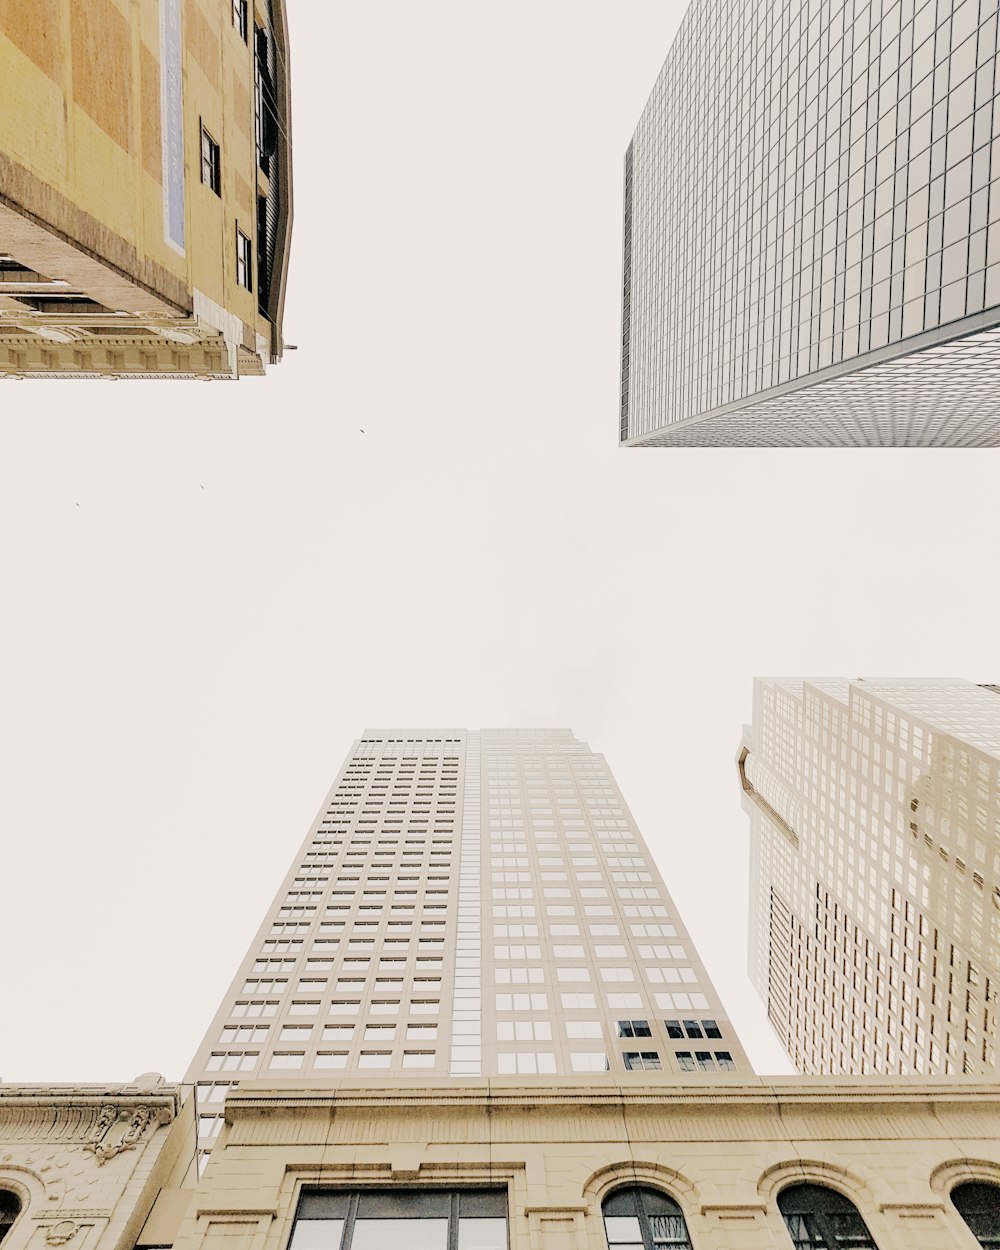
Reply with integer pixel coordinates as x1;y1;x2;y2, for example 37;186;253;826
289;1189;508;1250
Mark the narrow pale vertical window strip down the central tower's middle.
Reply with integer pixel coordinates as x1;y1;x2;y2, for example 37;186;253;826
451;731;483;1076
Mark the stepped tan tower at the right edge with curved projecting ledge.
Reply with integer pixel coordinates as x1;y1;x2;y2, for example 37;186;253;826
739;679;1000;1075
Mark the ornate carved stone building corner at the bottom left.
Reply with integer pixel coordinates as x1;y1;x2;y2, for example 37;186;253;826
0;1074;194;1250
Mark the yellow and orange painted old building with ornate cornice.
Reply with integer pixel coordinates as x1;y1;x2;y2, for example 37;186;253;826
0;0;291;379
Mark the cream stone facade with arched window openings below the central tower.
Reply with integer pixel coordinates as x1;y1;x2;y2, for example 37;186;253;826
167;1078;1000;1250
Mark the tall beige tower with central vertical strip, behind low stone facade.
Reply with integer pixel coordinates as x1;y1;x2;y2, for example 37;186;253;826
188;730;749;1170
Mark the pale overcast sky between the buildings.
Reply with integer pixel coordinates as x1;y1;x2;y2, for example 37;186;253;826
0;0;1000;1083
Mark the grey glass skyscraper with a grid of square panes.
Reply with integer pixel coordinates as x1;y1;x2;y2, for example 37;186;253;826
620;0;1000;446
